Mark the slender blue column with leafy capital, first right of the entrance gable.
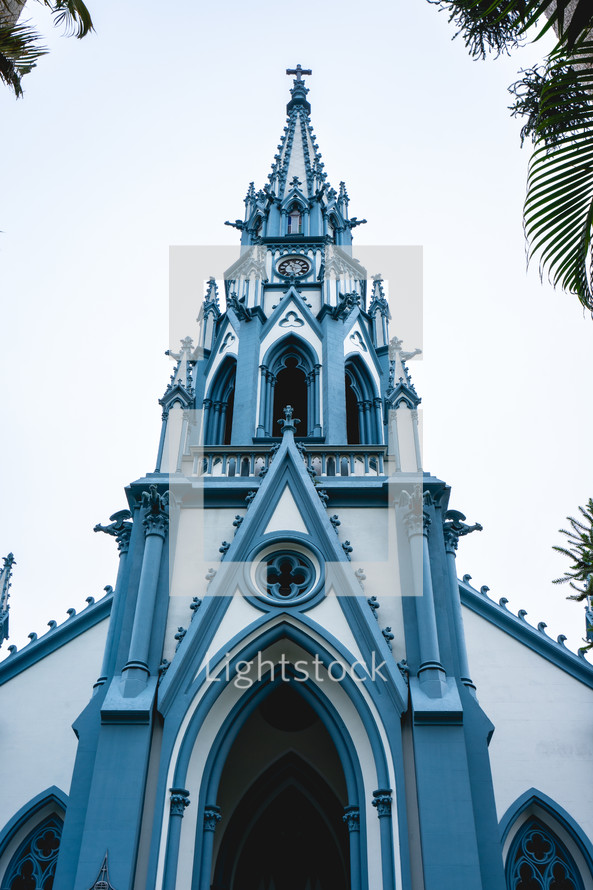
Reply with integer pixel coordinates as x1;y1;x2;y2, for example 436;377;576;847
400;486;445;698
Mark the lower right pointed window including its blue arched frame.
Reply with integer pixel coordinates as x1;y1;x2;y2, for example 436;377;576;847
500;788;593;890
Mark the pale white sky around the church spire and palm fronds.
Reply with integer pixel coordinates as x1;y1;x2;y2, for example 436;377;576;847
0;0;593;651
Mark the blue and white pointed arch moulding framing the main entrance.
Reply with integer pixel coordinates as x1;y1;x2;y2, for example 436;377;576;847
155;616;401;890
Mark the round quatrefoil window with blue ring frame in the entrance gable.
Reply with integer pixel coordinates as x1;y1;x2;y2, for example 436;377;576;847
244;539;325;610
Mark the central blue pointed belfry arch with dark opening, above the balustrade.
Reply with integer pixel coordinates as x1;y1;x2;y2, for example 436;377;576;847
258;334;321;436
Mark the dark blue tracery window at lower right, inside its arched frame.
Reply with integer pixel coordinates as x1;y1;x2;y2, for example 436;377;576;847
506;818;584;890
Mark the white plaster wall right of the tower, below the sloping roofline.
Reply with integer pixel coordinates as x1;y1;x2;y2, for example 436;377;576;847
463;608;593;837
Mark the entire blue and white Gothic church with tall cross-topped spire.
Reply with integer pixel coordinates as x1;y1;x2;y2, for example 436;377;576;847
0;65;593;890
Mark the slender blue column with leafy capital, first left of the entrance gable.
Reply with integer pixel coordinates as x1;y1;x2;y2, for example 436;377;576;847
124;485;169;696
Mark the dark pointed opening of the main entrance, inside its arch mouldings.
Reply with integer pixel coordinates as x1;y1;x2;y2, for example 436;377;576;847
213;682;350;890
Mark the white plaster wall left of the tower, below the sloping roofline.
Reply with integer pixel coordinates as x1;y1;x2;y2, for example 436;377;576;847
0;619;108;826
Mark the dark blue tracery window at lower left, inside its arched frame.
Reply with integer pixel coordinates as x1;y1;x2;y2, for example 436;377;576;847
2;815;63;890
